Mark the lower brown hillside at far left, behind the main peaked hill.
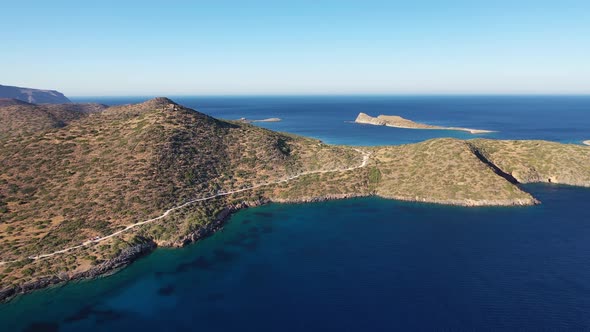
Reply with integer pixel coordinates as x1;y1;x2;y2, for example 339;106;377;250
0;99;107;139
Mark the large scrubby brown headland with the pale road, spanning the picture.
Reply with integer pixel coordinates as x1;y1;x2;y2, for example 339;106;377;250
0;98;590;300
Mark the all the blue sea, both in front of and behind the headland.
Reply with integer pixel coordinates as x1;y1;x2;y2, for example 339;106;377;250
0;96;590;331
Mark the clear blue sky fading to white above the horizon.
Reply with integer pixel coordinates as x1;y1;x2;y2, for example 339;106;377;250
0;0;590;96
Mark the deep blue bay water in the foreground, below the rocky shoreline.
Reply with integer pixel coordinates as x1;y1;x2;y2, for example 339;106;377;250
0;185;590;331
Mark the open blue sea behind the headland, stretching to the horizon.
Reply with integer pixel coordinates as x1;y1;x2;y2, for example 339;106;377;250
73;96;590;145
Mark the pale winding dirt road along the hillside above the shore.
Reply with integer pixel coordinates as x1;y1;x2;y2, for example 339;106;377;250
0;149;371;265
